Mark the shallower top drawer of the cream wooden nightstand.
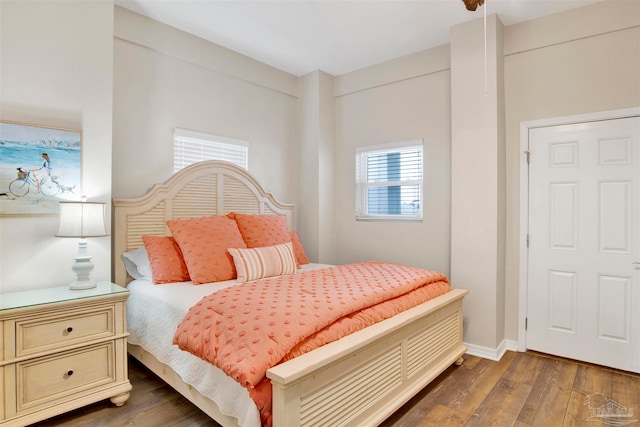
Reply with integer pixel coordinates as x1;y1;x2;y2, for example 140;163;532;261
16;306;114;357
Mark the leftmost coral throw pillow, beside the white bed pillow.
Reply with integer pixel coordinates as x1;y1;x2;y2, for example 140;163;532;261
142;236;189;284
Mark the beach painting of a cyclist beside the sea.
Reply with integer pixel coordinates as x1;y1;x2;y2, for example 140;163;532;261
0;121;82;215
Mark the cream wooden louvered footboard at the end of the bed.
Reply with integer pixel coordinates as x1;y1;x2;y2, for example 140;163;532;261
267;289;467;427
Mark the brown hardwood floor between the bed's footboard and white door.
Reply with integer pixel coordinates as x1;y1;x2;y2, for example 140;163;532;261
383;352;640;427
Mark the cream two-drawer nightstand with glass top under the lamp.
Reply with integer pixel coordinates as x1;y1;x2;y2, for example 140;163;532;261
0;282;131;427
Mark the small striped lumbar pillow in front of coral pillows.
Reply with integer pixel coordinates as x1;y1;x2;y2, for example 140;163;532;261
229;242;297;282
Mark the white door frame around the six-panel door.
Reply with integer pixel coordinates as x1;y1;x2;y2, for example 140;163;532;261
518;107;640;352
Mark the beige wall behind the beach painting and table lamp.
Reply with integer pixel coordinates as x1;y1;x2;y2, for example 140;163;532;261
0;0;113;292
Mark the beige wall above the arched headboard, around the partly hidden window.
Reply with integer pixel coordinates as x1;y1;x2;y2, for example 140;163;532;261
113;7;298;203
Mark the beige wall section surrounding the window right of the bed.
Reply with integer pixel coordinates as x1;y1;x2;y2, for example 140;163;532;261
332;46;451;274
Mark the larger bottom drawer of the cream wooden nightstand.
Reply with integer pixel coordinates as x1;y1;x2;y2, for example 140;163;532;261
16;341;115;412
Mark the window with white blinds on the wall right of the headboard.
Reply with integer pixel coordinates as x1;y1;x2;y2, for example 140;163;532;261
356;140;422;220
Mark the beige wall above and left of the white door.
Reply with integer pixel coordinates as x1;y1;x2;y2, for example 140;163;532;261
504;0;640;340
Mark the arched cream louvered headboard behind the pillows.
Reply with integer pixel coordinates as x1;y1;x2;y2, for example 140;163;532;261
113;160;295;286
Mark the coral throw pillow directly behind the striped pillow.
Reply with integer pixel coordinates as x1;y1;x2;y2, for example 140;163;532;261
228;213;291;248
